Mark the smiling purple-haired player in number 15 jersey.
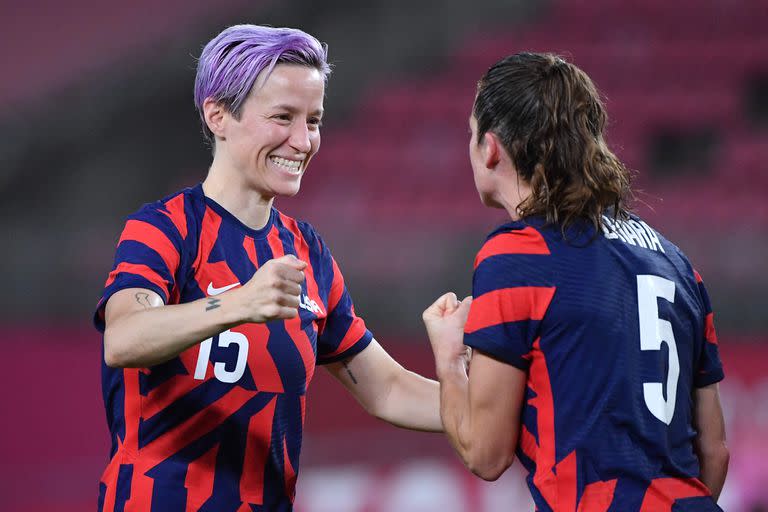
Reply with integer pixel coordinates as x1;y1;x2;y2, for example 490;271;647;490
95;25;442;512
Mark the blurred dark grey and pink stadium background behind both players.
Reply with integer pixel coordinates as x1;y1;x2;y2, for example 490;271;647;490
0;0;768;512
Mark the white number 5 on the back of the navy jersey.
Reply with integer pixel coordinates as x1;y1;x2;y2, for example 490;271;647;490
637;275;680;425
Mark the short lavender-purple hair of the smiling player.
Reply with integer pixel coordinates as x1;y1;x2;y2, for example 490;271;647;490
195;25;331;143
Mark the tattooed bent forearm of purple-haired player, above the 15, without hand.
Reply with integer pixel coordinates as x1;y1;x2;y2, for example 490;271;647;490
104;294;241;368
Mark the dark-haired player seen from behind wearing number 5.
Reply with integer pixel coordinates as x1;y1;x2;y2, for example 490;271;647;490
423;53;728;512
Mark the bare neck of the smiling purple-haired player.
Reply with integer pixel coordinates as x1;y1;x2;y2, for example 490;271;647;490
203;151;275;229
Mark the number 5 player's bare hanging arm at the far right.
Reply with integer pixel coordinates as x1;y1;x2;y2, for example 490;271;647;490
694;384;730;500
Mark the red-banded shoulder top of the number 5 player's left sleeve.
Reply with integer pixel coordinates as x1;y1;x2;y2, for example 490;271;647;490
475;221;550;268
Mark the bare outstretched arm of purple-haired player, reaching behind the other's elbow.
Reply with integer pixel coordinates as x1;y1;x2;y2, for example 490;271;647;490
326;340;443;432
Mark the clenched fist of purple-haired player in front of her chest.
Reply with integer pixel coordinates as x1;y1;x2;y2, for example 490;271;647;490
229;254;307;323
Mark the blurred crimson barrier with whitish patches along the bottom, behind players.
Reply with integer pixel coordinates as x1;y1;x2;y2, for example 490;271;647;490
0;326;768;512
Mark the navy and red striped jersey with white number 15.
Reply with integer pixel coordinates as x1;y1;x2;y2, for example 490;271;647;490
95;185;372;512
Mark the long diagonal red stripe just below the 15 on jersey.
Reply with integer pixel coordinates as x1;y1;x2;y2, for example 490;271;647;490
141;388;256;464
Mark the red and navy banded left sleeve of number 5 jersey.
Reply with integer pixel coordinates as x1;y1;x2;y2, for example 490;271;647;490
464;227;555;370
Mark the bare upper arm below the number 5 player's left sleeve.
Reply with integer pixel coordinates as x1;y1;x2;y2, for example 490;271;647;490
469;350;527;454
